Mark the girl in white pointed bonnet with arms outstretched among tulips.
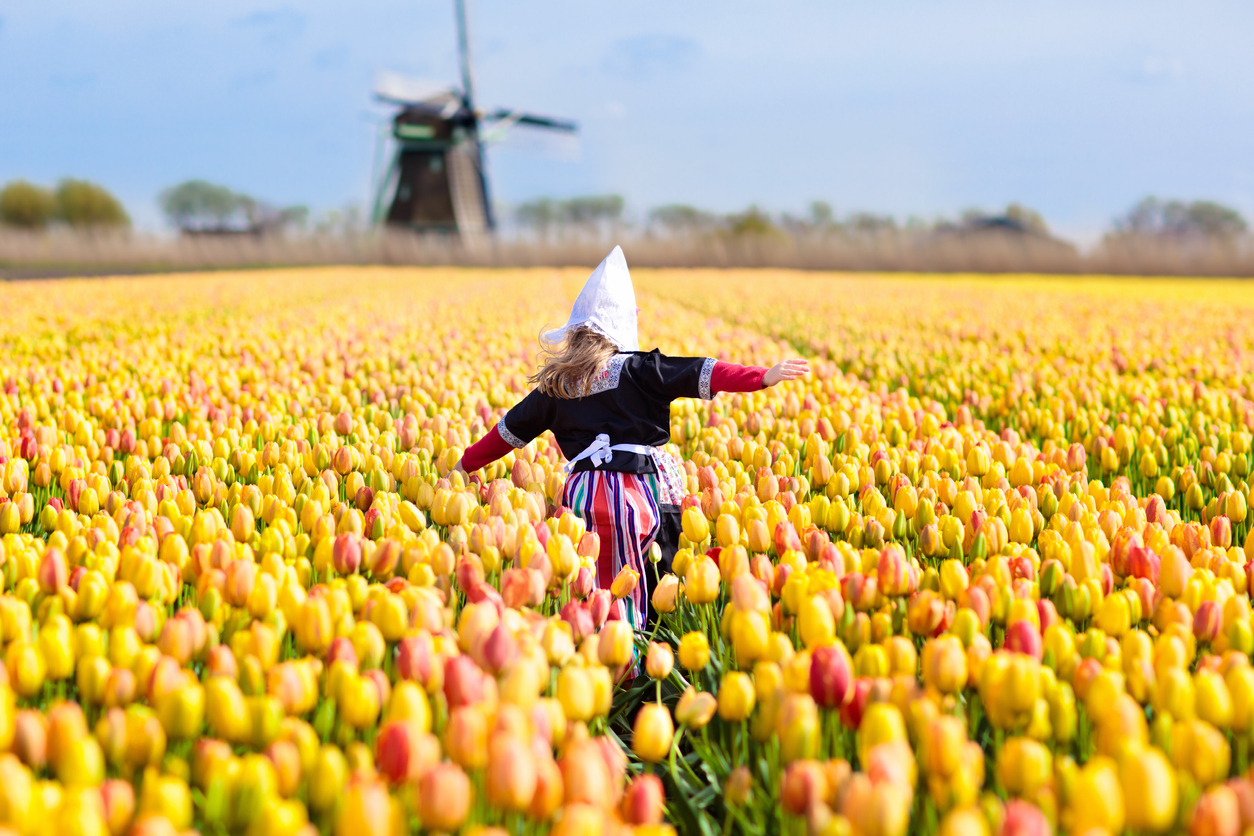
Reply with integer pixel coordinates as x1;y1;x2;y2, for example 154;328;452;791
458;247;809;630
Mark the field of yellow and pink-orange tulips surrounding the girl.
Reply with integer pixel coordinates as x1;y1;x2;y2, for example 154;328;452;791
0;267;1254;836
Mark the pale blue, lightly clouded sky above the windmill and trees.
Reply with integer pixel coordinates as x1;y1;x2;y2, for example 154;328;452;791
0;0;1254;242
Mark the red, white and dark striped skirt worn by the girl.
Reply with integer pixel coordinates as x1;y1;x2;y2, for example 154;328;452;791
562;470;662;630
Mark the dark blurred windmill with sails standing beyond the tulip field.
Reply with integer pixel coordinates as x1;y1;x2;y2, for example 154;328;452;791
374;0;576;236
